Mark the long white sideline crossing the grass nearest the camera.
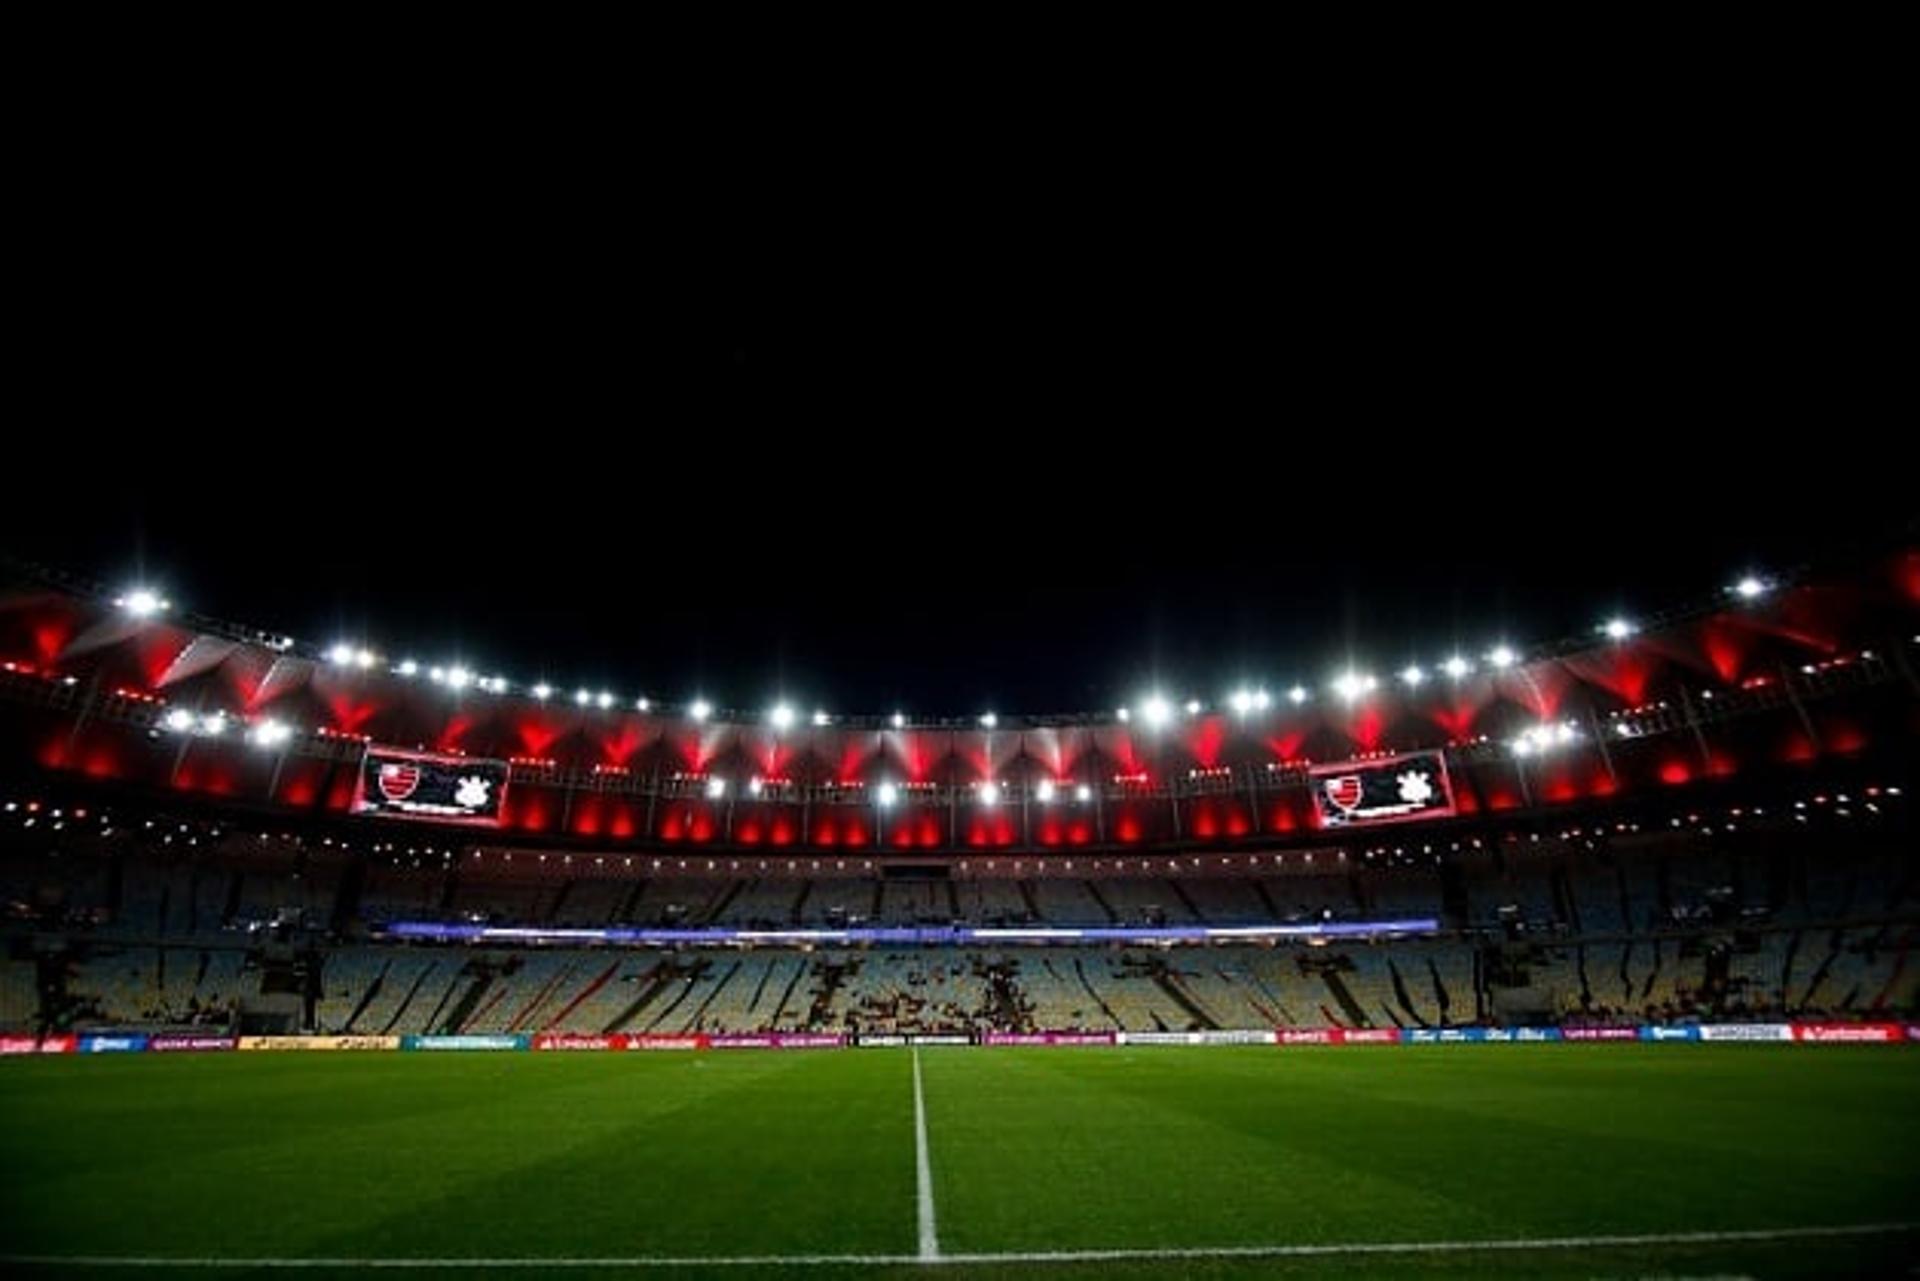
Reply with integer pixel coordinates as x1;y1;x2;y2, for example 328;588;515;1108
0;1223;1920;1271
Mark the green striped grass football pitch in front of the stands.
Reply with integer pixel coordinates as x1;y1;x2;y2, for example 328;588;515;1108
0;1045;1920;1281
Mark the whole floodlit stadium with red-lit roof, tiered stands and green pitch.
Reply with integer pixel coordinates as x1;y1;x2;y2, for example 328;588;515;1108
0;544;1920;1275
